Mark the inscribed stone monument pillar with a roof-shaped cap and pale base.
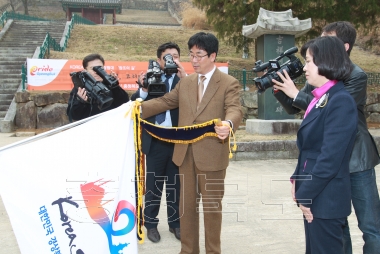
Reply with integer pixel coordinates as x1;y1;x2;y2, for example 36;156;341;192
242;8;311;135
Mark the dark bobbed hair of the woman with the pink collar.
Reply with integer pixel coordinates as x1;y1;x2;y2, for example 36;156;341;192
301;36;353;80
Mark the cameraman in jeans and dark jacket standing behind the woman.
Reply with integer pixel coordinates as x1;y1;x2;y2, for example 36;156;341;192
272;21;380;254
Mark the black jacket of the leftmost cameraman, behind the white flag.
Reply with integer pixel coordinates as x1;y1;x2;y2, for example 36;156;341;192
66;87;129;121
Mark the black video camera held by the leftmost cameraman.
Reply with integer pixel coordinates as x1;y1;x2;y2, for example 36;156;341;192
70;71;113;110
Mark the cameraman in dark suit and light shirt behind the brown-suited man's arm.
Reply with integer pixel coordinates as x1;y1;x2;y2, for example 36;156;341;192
131;42;186;243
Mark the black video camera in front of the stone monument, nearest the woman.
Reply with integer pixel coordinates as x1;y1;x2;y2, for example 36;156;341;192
253;47;303;93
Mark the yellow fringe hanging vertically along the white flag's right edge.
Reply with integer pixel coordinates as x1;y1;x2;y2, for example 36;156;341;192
127;101;145;244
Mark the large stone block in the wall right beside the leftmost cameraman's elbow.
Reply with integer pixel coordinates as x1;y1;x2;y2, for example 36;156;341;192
37;103;69;129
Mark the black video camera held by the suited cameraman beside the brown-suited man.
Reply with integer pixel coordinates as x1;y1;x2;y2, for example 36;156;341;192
142;60;166;97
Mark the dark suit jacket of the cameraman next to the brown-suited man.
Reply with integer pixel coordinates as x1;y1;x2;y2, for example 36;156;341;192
131;75;179;155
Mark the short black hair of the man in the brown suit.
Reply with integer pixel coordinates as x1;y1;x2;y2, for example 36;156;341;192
187;32;219;56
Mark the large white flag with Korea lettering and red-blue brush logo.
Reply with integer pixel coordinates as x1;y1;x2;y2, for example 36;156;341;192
0;102;137;254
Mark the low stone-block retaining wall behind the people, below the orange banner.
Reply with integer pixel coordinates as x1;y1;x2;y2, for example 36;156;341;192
15;91;380;129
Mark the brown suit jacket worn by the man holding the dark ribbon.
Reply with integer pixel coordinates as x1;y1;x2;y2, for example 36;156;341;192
142;68;242;171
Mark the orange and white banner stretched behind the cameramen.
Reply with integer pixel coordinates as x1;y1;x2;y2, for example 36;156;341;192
27;59;228;91
